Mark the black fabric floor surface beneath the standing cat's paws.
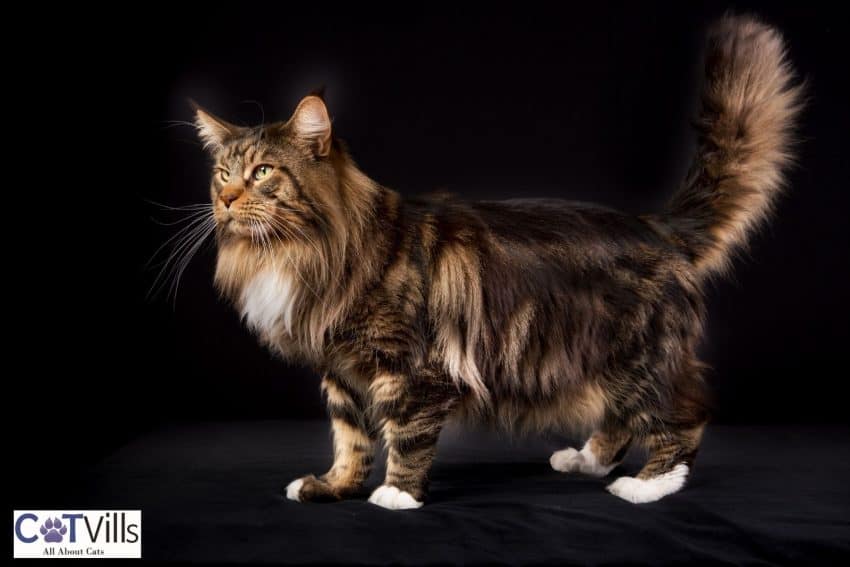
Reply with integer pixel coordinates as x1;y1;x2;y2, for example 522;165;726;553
68;422;850;564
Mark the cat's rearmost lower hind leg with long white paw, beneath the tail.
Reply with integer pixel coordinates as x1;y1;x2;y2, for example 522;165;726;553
608;423;705;504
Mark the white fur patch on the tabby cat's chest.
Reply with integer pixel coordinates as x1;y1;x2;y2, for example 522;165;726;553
242;268;298;338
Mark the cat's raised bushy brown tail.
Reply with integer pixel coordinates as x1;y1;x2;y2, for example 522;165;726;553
667;15;803;274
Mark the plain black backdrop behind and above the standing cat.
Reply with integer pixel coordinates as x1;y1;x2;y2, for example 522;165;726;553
4;2;850;506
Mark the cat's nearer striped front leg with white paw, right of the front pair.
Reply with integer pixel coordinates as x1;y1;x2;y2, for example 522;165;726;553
369;372;458;510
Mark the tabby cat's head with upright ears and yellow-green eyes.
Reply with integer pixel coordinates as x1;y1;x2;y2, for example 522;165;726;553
196;96;337;247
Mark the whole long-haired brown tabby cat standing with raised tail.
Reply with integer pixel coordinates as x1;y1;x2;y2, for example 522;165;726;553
187;16;801;509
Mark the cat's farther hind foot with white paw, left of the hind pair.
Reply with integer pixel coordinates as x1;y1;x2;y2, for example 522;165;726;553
549;427;631;477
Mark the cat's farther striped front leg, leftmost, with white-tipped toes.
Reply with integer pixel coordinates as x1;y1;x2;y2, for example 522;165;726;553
286;375;375;502
